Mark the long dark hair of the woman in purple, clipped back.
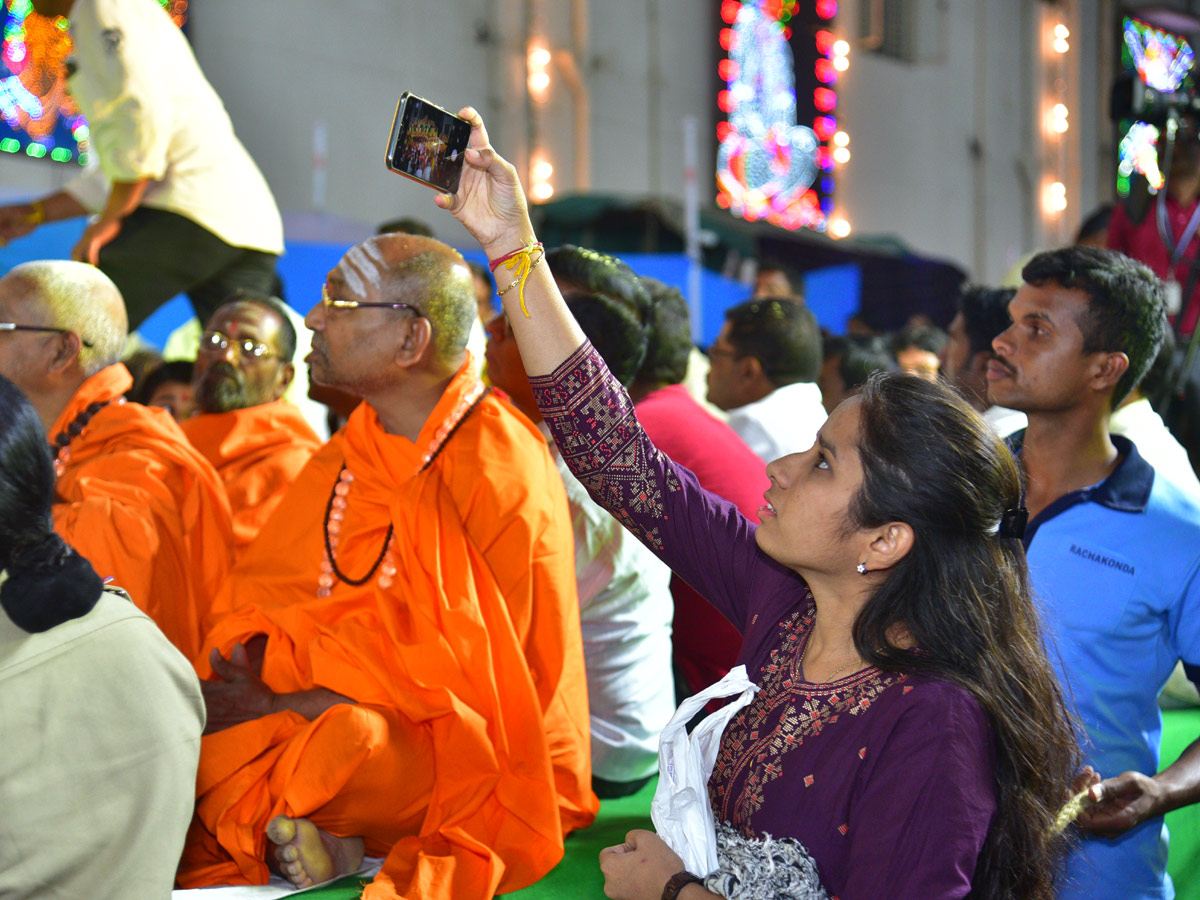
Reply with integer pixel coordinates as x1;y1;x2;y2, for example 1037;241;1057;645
847;373;1080;900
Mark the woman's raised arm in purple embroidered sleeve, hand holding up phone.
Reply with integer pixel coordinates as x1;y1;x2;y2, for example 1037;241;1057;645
437;108;794;630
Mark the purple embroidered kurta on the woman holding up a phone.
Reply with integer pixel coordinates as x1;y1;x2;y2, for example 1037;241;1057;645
530;343;996;900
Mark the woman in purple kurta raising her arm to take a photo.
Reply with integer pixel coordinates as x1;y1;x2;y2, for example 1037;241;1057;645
438;109;1078;900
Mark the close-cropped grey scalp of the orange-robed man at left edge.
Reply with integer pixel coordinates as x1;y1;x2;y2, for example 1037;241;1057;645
0;259;128;378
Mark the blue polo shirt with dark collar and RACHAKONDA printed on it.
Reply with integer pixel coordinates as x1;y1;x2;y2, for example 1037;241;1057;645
1010;432;1200;900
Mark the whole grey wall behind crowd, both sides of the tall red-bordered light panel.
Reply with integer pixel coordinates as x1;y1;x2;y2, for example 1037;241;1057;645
0;0;1111;281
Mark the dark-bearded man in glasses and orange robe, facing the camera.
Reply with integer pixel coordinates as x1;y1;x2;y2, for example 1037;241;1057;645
182;292;322;556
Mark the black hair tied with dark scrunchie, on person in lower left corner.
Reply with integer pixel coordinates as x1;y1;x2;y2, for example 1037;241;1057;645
0;376;102;634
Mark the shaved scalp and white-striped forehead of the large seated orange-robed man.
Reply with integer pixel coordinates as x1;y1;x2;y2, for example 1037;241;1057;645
338;234;476;365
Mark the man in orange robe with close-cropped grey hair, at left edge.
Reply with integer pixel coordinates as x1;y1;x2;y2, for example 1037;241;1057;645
0;260;233;659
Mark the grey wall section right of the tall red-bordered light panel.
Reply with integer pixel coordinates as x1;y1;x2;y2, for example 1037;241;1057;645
839;0;1114;282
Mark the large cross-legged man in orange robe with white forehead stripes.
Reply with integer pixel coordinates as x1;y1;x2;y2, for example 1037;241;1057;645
180;235;598;900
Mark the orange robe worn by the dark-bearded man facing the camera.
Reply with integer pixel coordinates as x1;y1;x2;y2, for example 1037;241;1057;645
181;400;320;556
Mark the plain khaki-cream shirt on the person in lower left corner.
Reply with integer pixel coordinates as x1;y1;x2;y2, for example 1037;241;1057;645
0;572;204;900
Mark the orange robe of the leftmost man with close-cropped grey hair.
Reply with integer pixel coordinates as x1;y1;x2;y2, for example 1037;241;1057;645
50;364;233;659
